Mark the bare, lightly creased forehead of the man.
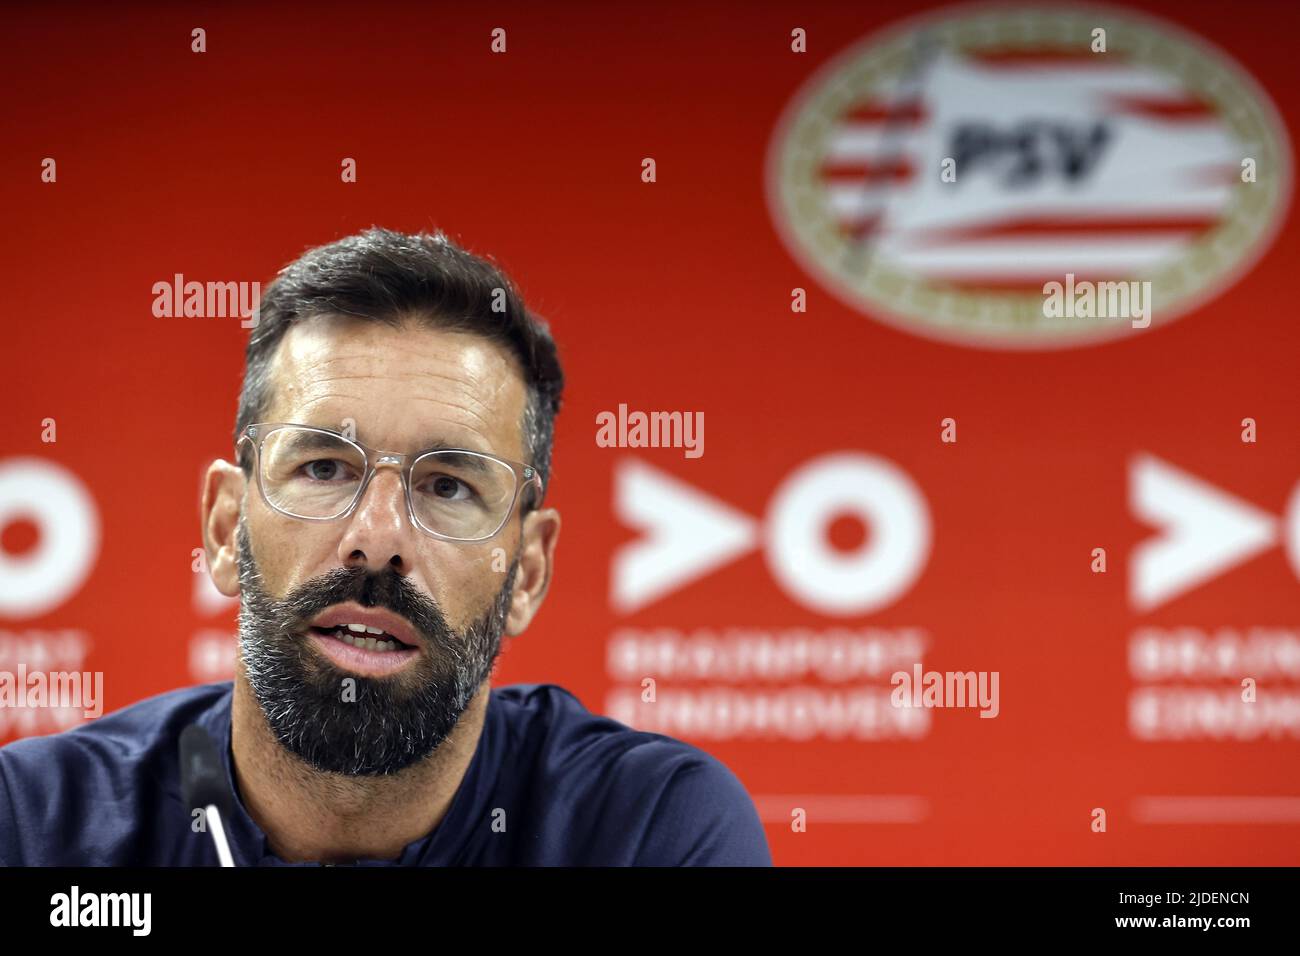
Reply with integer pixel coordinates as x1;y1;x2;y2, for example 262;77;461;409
265;316;528;460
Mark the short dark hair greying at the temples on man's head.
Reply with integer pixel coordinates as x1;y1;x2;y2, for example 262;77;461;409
234;226;564;511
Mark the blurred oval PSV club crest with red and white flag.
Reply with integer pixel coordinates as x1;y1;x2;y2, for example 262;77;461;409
767;7;1291;349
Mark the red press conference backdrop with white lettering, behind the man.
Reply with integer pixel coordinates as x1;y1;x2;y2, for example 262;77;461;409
0;1;1300;865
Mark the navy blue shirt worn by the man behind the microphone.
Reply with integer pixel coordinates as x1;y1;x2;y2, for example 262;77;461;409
0;682;771;866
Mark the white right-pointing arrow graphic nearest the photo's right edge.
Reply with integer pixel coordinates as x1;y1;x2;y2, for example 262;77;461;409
1128;455;1278;611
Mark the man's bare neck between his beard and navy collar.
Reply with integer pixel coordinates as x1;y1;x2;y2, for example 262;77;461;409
230;667;491;862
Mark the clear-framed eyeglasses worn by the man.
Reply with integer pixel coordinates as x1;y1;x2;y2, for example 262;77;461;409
235;421;542;541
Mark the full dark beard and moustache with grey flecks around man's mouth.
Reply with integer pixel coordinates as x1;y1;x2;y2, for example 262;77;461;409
238;518;519;777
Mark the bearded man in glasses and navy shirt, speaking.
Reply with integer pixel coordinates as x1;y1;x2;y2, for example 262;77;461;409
0;229;771;866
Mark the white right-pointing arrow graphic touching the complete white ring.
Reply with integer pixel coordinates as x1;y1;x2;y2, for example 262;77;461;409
610;458;758;613
